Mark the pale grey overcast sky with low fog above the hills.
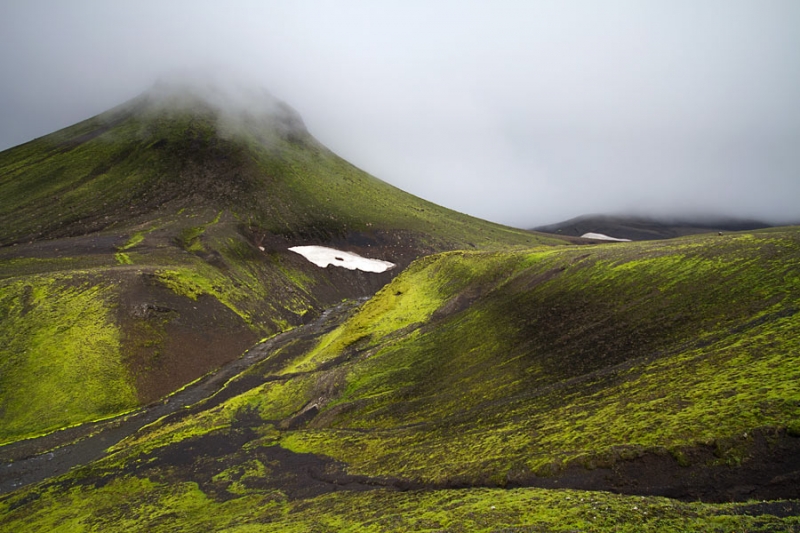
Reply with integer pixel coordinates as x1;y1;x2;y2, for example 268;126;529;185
0;0;800;227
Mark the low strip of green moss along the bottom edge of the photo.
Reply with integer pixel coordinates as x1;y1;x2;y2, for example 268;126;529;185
0;478;800;533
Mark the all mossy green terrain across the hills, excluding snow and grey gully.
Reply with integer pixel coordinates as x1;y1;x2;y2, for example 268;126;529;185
0;86;800;532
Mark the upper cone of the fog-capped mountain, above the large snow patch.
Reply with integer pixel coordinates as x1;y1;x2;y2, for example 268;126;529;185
0;86;561;250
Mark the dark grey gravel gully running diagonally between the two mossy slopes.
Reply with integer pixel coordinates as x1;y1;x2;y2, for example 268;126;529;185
0;300;363;494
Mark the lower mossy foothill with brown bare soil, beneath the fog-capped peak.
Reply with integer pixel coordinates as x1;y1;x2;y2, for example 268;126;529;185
0;214;368;444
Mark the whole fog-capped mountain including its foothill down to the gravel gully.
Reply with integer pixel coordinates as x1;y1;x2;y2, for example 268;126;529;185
0;85;560;443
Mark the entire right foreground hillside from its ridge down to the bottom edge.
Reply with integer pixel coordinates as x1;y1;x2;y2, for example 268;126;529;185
0;228;800;532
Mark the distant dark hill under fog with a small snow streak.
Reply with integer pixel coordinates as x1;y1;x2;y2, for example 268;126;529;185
534;215;770;241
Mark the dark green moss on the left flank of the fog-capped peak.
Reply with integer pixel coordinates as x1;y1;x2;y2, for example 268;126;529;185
0;112;174;240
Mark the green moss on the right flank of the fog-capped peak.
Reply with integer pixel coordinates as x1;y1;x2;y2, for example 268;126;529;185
250;133;559;248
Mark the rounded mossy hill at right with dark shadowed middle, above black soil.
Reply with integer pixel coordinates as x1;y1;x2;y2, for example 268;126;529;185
282;229;800;484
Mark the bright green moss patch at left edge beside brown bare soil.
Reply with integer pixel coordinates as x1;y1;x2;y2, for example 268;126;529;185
0;274;137;442
